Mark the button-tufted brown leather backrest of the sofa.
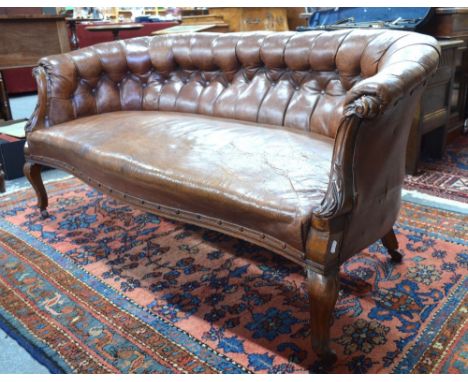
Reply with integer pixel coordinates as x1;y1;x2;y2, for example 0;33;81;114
36;30;433;137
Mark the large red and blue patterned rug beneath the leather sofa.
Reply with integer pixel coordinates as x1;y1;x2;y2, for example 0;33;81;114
0;178;468;373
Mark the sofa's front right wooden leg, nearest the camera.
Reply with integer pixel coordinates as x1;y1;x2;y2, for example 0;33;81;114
307;269;339;366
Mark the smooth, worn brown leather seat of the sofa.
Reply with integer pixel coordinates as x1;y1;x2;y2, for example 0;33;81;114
28;111;333;251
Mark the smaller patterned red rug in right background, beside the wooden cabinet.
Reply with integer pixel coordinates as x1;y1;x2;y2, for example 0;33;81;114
405;136;468;203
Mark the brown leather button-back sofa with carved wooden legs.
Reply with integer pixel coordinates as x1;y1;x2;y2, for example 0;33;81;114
25;30;440;362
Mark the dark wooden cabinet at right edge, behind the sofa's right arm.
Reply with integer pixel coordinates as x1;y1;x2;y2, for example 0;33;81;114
407;7;468;174
